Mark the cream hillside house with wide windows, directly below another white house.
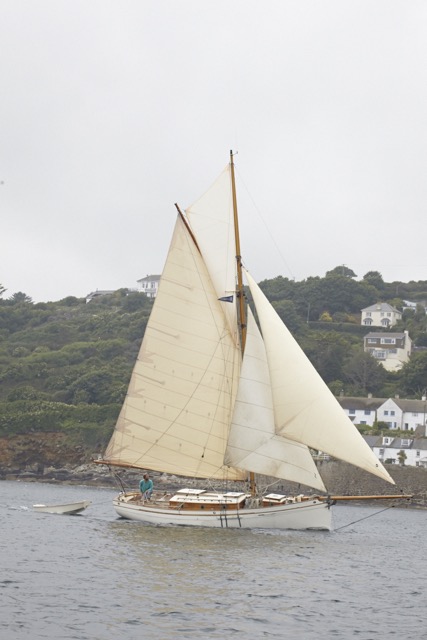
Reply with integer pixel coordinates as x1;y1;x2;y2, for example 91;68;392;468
363;330;412;371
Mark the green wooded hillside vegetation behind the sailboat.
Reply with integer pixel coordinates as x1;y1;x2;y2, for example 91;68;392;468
0;267;427;468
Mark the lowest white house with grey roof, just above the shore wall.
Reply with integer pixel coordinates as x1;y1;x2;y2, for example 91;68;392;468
365;436;427;467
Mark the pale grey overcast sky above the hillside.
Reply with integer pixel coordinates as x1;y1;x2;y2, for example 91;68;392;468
0;0;427;302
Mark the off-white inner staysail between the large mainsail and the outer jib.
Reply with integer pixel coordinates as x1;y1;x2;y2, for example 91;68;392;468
225;308;326;491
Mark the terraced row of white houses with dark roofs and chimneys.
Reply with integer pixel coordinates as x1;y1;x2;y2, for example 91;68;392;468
337;396;427;436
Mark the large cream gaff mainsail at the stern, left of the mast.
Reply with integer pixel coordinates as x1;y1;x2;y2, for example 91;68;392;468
105;216;247;480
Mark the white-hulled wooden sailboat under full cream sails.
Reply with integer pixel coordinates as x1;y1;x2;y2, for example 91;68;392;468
96;152;401;530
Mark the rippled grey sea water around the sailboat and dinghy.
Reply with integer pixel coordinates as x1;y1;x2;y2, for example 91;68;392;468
0;481;427;640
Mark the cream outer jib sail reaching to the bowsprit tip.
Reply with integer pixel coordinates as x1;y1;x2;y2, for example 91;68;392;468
245;271;394;484
